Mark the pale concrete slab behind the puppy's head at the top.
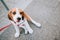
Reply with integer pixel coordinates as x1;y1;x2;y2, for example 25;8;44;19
4;0;32;9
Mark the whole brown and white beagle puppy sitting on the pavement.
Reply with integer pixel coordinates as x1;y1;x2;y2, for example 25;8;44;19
8;8;41;37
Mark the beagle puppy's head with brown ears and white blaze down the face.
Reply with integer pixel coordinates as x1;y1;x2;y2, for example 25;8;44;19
8;8;24;22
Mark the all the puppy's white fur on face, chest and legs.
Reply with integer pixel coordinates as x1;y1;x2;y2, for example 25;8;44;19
11;8;41;37
